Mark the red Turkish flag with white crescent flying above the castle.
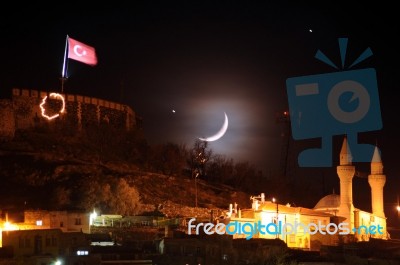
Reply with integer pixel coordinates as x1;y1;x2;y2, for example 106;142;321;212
68;37;97;65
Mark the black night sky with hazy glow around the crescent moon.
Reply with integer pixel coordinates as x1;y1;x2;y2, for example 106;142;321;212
0;1;400;221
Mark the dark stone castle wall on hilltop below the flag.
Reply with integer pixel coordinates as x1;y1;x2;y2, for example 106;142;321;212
0;88;137;140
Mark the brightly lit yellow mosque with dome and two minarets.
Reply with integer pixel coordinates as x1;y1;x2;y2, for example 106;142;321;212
227;137;389;250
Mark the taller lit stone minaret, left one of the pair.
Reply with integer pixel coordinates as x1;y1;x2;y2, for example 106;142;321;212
337;137;356;229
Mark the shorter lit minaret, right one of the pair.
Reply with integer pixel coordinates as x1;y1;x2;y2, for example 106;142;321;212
368;147;386;217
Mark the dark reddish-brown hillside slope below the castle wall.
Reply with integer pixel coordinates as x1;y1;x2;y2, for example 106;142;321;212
0;127;250;216
